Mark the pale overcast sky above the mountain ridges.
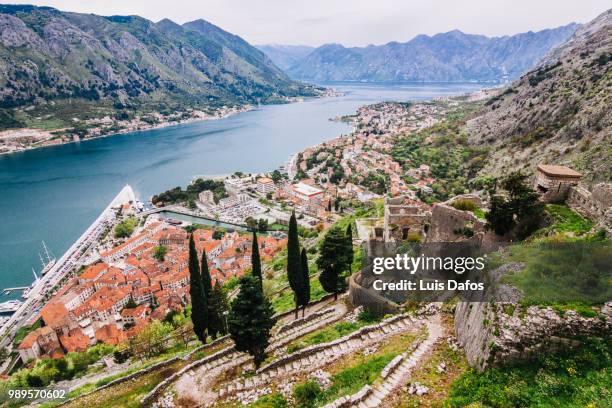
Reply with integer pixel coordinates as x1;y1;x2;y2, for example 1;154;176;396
8;0;610;46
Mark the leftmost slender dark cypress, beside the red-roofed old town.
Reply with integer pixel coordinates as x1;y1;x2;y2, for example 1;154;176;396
189;235;208;343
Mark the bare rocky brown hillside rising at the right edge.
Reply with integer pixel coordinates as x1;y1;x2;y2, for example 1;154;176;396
468;10;612;182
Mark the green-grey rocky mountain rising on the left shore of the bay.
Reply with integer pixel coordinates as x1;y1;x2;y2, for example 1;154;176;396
0;5;312;127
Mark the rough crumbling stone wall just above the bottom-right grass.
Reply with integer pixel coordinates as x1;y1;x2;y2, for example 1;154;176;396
455;302;612;370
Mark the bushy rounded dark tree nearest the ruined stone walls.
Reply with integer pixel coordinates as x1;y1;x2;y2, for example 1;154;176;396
317;227;349;299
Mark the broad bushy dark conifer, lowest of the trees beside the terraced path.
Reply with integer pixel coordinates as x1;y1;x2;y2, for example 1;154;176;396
227;276;274;368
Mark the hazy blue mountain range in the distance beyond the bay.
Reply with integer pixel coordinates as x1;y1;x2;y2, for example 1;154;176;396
282;24;578;81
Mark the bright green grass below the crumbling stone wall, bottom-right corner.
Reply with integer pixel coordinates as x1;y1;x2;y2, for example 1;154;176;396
445;338;612;408
